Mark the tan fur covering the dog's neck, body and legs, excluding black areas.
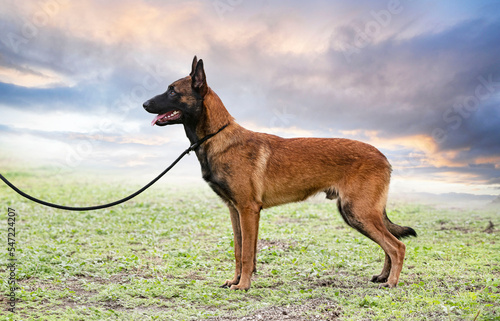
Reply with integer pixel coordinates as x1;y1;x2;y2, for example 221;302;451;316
195;90;405;289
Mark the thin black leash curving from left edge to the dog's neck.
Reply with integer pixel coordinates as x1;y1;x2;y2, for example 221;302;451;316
0;124;229;211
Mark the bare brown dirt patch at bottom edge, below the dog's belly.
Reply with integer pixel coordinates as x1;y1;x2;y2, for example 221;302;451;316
208;299;342;321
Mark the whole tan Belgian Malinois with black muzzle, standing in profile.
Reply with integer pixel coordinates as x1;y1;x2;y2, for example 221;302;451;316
143;56;416;290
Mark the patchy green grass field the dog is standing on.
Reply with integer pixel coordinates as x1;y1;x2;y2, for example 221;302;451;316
0;171;500;320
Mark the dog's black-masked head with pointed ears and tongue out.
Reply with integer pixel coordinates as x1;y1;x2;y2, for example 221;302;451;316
142;56;208;126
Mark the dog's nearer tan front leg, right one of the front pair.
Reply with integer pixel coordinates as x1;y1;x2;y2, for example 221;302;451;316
231;203;261;290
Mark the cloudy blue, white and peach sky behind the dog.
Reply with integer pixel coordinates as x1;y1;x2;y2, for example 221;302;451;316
0;0;500;195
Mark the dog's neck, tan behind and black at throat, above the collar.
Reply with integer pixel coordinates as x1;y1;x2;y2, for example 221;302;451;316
184;88;234;144
